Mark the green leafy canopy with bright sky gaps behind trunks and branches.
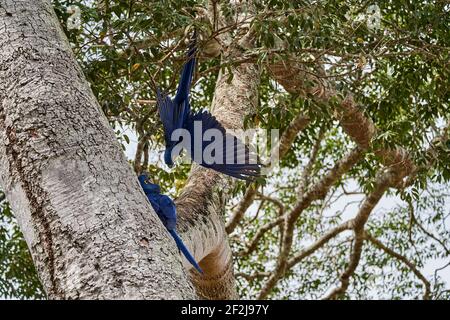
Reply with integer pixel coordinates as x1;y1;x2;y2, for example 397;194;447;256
0;0;450;299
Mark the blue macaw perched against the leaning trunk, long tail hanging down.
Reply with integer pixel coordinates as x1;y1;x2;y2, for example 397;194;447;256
138;174;203;273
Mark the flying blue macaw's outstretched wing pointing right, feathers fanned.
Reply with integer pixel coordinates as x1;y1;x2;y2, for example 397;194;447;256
186;111;262;181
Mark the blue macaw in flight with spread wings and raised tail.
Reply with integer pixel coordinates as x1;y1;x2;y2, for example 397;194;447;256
157;34;261;181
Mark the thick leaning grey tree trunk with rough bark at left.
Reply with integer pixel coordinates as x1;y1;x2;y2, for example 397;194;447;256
0;0;195;299
